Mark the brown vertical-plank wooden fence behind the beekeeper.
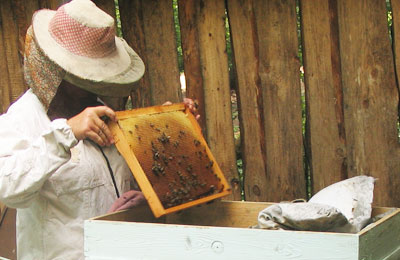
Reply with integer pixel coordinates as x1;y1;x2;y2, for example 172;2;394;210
0;0;400;217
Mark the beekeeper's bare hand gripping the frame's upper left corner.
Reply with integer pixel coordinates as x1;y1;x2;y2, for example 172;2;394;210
67;106;117;146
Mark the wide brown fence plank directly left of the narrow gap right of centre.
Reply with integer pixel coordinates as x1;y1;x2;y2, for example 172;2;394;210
253;0;306;202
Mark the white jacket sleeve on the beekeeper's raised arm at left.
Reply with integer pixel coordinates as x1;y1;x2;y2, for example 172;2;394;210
0;115;78;208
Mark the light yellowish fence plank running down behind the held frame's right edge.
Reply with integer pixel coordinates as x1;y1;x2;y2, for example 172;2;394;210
198;0;240;200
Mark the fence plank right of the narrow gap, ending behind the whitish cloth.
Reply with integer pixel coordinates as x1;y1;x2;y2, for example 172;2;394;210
300;0;347;193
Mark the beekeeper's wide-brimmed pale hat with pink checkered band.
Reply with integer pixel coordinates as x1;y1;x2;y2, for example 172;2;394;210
32;0;144;97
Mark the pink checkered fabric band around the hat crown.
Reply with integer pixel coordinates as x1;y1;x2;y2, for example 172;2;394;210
49;7;116;58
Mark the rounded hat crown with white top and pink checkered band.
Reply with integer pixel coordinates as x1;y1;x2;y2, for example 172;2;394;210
49;0;116;58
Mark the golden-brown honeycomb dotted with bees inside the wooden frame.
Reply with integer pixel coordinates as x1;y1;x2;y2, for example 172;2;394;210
118;107;224;209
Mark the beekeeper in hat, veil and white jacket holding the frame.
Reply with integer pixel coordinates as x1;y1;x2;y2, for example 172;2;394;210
0;0;198;260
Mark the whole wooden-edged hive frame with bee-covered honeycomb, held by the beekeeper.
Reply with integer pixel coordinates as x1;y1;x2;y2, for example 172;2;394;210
109;103;231;217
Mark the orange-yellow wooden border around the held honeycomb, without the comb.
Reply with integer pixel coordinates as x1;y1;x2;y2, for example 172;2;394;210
109;103;231;217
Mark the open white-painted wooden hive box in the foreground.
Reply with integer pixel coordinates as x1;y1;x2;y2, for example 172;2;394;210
84;200;400;260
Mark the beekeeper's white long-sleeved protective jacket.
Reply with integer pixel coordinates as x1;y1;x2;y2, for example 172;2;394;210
0;90;133;260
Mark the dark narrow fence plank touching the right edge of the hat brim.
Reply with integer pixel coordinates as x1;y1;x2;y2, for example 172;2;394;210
119;0;152;108
